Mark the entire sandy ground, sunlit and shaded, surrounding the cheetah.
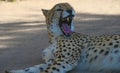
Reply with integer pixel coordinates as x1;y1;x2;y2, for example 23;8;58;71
0;0;120;73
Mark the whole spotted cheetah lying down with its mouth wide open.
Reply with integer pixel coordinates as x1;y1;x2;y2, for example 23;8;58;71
6;3;120;73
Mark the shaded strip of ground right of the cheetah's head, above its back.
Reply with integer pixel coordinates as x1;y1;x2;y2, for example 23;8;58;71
75;13;120;35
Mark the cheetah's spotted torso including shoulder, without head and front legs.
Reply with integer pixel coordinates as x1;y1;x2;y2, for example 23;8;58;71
43;33;120;72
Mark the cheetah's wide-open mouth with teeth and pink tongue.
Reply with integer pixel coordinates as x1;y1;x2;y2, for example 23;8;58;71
59;16;73;36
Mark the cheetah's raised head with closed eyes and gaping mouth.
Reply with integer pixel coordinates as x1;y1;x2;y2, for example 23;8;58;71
42;3;75;43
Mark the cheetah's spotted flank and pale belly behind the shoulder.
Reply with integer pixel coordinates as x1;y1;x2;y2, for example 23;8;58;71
77;35;120;72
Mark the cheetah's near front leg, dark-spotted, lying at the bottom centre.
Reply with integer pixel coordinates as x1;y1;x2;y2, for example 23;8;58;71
41;60;75;73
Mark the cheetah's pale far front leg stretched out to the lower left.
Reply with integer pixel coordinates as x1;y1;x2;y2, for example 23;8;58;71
6;44;56;73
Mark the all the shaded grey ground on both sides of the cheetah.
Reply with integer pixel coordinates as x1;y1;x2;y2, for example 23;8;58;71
0;13;120;73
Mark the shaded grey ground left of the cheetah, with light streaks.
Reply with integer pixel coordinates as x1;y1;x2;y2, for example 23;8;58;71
0;21;48;73
